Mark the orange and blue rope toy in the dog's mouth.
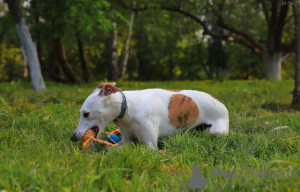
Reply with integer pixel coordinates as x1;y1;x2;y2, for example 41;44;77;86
82;129;121;149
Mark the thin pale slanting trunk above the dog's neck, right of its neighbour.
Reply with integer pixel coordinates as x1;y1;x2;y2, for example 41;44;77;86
120;1;136;79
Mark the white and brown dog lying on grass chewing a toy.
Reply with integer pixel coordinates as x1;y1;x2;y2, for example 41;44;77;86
71;83;229;148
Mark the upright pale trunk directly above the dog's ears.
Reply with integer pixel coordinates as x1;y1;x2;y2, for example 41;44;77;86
107;22;119;81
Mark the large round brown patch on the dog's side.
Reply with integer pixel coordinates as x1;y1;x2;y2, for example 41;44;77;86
168;94;199;129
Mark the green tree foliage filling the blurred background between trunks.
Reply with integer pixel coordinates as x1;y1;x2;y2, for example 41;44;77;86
0;0;295;81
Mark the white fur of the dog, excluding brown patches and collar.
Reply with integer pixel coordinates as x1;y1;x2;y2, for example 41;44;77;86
72;89;229;148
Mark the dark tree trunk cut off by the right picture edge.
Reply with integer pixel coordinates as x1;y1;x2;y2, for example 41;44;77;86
291;0;300;110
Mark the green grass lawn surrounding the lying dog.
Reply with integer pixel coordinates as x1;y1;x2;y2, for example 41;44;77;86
0;81;300;192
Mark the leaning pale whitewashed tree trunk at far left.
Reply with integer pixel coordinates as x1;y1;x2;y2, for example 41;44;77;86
6;0;46;91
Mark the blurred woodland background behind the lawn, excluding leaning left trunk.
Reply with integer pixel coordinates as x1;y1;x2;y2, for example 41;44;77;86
0;0;295;83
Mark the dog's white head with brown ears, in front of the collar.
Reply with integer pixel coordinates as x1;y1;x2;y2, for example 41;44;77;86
71;83;120;141
